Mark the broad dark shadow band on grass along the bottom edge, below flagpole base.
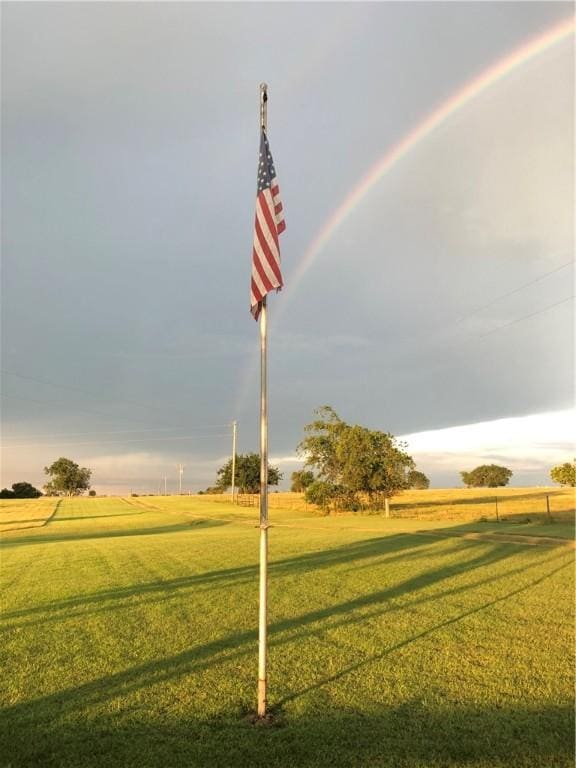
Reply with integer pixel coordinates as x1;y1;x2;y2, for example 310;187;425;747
0;700;574;768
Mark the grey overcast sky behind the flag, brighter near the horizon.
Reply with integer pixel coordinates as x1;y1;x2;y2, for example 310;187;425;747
2;2;574;492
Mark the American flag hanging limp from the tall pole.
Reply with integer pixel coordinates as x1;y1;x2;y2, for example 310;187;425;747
250;130;286;320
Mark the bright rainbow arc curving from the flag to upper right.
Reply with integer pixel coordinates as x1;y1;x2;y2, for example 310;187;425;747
273;17;575;322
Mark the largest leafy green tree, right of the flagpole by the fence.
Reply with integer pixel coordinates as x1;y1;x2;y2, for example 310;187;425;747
297;406;414;510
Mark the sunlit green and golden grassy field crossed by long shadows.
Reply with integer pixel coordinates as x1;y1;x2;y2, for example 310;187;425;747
0;489;574;768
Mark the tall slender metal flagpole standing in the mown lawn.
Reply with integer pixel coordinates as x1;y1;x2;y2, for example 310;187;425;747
258;83;268;717
